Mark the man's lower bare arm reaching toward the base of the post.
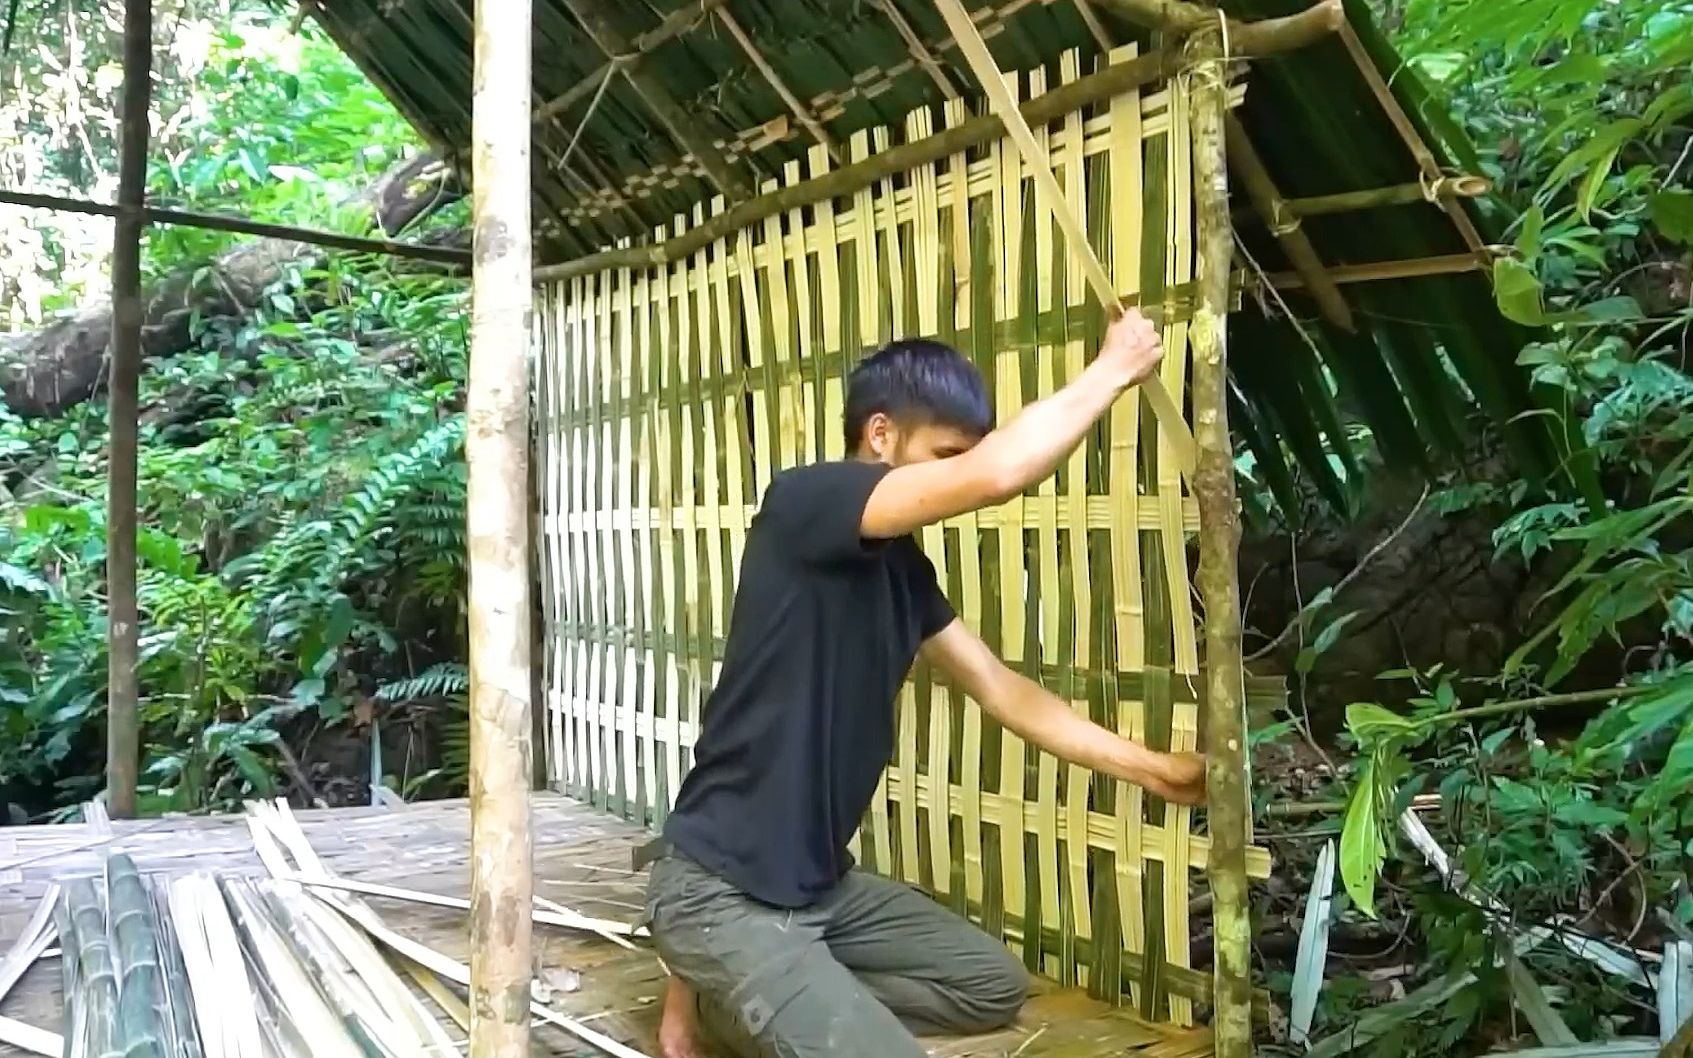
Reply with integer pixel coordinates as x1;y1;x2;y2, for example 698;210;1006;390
923;620;1205;804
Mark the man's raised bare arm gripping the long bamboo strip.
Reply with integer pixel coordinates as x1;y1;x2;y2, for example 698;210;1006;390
860;310;1163;540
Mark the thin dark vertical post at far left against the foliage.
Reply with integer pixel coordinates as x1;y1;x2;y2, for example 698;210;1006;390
107;0;152;819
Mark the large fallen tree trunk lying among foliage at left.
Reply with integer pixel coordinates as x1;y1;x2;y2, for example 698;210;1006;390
0;154;464;418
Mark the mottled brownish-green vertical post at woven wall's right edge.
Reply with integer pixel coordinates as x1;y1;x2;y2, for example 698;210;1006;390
1188;27;1253;1058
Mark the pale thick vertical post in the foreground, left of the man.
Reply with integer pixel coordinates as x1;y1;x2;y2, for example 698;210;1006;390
464;0;533;1058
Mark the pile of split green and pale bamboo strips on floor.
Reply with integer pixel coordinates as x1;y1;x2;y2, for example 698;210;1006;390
0;804;645;1058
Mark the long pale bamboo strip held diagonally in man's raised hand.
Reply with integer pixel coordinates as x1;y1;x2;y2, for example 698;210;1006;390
934;0;1198;477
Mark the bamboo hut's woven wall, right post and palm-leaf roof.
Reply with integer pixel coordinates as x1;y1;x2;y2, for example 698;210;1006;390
294;0;1558;1055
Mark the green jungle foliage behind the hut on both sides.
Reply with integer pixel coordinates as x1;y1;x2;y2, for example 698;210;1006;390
0;0;1693;1055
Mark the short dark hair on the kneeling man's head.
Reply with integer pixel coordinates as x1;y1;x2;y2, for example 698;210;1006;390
847;339;994;452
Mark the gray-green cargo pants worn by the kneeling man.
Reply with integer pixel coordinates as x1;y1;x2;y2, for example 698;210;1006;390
647;851;1029;1058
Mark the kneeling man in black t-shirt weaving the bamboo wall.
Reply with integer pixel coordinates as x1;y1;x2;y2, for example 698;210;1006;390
647;311;1204;1058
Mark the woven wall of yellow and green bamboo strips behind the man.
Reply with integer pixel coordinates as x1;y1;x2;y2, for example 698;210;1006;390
537;52;1280;1024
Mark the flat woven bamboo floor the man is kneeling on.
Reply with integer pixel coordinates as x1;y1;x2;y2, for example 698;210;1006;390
0;792;1210;1058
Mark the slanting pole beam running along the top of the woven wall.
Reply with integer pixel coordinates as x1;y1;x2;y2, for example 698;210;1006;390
535;51;1180;281
